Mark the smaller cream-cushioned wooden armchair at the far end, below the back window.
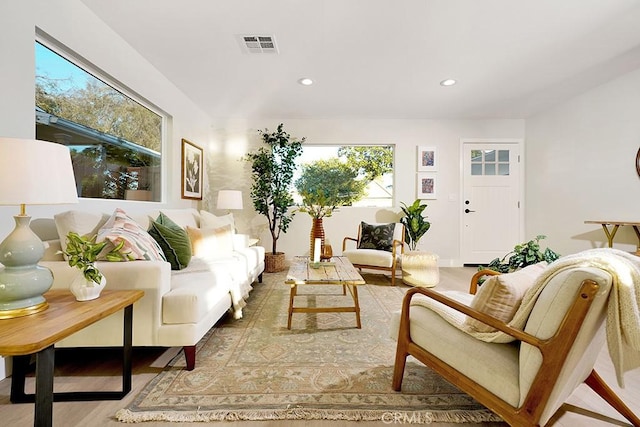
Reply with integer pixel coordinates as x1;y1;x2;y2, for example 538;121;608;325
342;223;404;286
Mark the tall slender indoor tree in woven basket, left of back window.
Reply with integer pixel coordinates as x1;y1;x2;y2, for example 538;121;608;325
245;123;305;273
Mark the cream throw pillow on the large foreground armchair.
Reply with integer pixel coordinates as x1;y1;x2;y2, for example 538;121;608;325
465;262;547;332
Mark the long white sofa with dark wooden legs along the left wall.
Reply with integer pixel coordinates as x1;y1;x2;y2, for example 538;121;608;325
32;209;264;370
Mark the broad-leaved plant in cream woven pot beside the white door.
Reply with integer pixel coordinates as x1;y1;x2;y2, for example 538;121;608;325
400;199;440;286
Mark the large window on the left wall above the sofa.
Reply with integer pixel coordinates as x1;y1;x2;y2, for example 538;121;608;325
35;42;163;202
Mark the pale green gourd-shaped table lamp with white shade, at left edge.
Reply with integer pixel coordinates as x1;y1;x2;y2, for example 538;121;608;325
0;138;78;324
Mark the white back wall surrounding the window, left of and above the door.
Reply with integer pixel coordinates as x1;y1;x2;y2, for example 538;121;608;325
204;119;524;266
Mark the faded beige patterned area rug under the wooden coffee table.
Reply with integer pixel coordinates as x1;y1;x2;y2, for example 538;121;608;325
116;273;500;423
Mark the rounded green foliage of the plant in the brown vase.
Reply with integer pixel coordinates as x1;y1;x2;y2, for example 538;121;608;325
295;158;367;218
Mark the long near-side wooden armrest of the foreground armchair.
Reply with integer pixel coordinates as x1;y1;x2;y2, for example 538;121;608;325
400;287;543;348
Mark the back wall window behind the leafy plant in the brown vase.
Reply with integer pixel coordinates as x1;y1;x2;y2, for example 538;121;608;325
294;145;394;207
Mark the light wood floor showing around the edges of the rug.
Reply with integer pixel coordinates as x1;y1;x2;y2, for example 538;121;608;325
0;267;640;427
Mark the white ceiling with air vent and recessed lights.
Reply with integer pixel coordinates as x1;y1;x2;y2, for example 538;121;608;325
82;0;640;119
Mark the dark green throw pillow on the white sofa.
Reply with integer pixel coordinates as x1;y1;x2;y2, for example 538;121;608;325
149;212;191;270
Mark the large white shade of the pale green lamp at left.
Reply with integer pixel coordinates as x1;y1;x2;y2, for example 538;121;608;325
0;138;78;205
